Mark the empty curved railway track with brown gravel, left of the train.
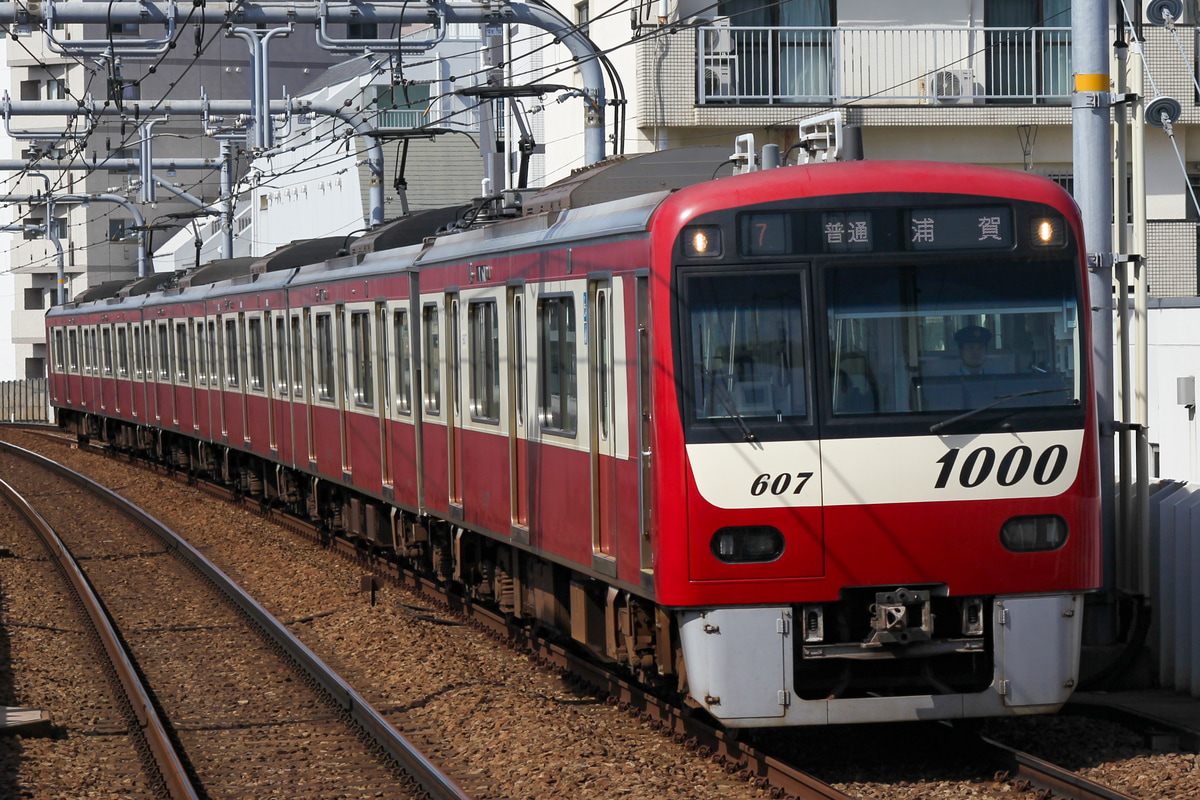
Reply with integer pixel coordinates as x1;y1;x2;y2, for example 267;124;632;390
0;443;468;800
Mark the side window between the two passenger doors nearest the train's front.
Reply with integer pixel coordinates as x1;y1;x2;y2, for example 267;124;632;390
538;297;578;435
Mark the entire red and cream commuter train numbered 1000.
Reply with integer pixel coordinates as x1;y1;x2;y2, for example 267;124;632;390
47;151;1100;727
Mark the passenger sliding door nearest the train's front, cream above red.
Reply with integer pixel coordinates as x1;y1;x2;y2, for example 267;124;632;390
584;278;618;575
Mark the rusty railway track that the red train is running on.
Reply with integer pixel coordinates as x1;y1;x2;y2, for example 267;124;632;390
0;424;1176;800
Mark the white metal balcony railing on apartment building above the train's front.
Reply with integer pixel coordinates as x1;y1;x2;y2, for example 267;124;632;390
696;25;1072;106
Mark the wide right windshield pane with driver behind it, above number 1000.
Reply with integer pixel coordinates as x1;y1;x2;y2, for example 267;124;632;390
826;260;1084;416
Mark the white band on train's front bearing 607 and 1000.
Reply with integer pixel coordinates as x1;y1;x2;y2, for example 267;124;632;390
688;429;1084;509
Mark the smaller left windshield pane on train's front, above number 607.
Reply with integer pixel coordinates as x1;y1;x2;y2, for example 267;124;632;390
684;270;808;425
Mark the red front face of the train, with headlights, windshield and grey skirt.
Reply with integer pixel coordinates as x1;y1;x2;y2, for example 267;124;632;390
653;162;1100;727
